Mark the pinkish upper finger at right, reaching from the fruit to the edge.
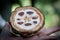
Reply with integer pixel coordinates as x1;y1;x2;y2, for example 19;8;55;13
40;27;60;35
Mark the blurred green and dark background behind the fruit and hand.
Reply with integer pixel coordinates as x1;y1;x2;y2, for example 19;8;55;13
0;0;60;40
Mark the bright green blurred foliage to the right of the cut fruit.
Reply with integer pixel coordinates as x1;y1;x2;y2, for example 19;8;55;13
34;1;59;28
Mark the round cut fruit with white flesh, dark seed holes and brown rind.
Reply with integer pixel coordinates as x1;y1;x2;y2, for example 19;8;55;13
10;6;44;36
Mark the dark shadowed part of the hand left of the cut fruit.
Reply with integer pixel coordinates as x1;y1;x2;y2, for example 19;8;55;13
0;22;11;40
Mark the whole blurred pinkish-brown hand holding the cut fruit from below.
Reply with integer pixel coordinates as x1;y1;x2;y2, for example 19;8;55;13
0;22;60;40
